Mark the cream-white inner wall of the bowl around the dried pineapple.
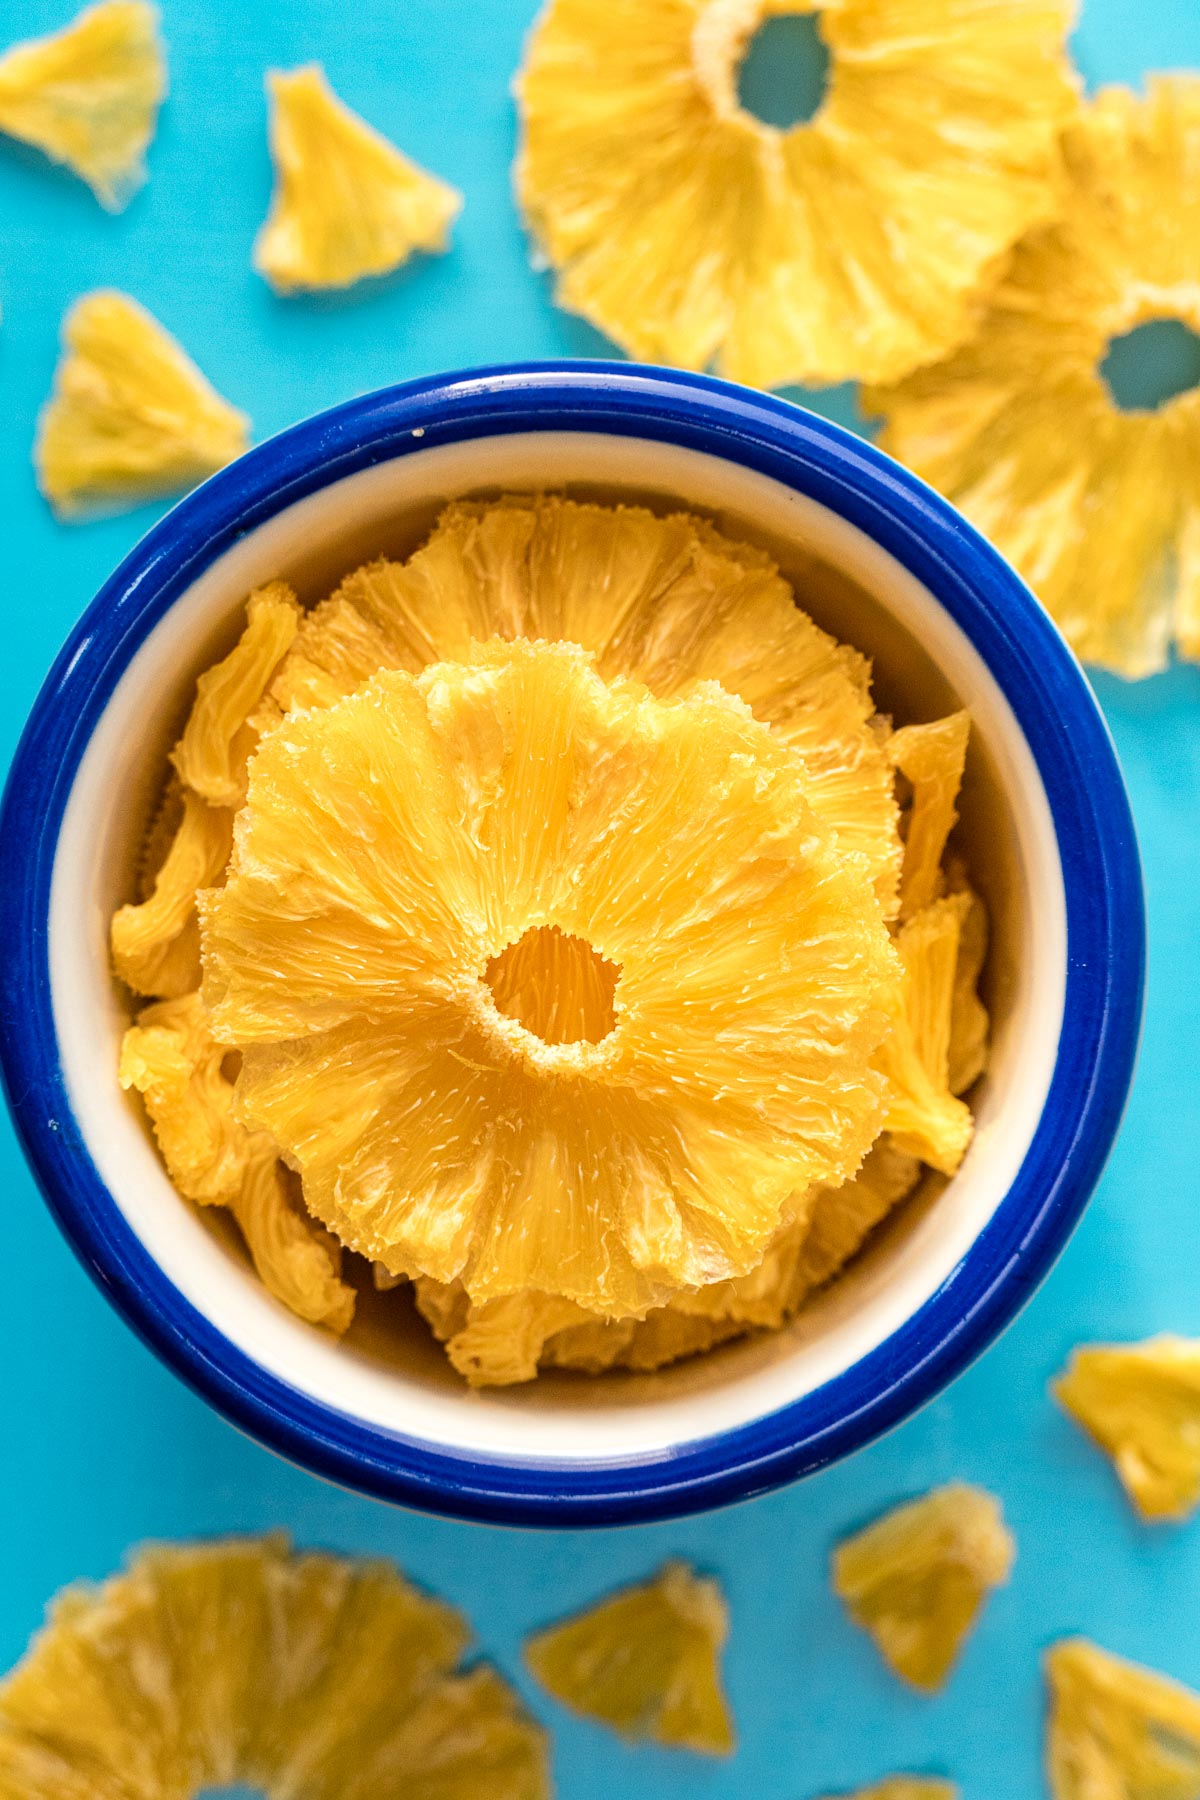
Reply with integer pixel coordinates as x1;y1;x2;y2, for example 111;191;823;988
50;432;1067;1465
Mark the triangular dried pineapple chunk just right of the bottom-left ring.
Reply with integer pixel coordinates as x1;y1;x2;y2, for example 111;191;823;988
525;1562;734;1757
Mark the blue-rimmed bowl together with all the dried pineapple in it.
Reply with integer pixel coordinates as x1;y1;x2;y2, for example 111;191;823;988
0;364;1144;1523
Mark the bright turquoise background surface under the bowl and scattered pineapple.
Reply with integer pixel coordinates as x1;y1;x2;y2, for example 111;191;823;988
0;0;1200;1800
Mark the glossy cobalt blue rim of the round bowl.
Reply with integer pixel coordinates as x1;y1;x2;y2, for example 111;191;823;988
0;362;1146;1526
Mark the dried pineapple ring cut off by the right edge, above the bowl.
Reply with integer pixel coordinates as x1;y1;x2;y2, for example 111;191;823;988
865;76;1200;679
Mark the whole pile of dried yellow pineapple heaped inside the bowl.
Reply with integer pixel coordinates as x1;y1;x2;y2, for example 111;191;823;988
112;497;986;1382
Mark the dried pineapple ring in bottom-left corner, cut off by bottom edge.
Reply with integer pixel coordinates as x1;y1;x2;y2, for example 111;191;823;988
0;1535;551;1800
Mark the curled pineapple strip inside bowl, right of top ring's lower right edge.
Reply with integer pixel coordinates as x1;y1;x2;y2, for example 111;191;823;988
876;893;973;1175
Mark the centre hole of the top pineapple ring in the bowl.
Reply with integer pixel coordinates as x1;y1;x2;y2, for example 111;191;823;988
484;925;621;1044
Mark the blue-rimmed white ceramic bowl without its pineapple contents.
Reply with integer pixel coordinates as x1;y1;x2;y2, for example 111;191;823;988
0;364;1144;1525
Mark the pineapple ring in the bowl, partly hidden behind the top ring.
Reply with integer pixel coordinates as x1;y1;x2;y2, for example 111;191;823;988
272;497;901;911
